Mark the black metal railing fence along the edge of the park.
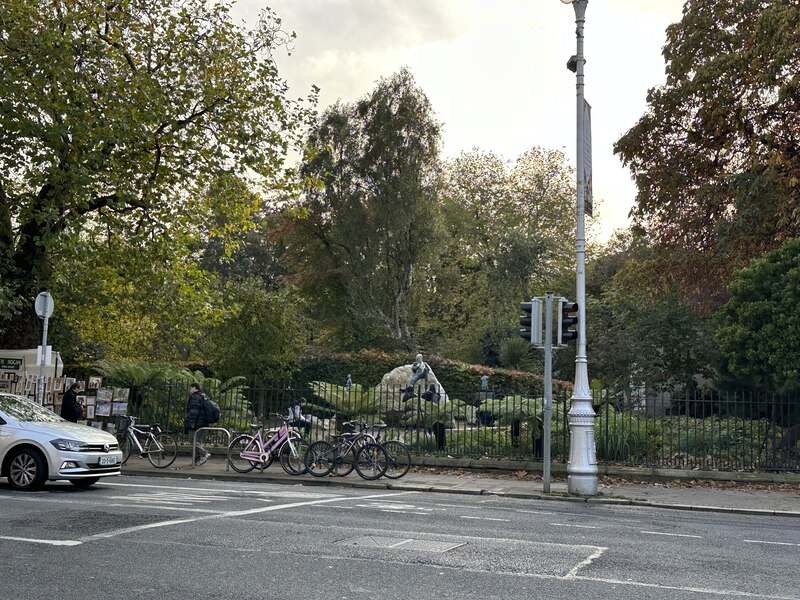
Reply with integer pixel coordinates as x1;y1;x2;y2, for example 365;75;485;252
103;382;800;471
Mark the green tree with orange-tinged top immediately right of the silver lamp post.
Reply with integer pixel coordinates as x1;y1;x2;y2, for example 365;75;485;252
580;233;713;390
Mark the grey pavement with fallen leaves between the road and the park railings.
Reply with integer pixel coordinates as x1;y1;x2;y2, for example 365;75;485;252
122;451;800;518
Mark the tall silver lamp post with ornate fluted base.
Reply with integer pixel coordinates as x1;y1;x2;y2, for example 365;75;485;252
561;0;597;496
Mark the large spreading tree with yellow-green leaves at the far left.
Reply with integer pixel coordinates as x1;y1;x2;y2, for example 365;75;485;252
0;0;307;346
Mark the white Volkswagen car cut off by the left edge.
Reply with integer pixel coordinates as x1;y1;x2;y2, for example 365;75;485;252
0;393;122;490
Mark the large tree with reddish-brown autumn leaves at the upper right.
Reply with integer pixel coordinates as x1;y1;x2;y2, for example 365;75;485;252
615;0;800;309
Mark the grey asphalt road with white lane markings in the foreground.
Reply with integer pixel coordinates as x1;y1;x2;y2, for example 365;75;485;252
0;477;800;600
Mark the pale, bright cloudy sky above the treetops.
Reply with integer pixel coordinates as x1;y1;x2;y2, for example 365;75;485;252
228;0;684;242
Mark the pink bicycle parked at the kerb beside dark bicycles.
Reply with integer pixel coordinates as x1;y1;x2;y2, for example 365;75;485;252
228;413;308;475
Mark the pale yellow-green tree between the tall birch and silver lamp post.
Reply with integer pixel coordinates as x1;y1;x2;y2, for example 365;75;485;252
420;148;575;365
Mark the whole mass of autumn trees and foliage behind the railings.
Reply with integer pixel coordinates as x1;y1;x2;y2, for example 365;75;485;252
0;0;800;418
